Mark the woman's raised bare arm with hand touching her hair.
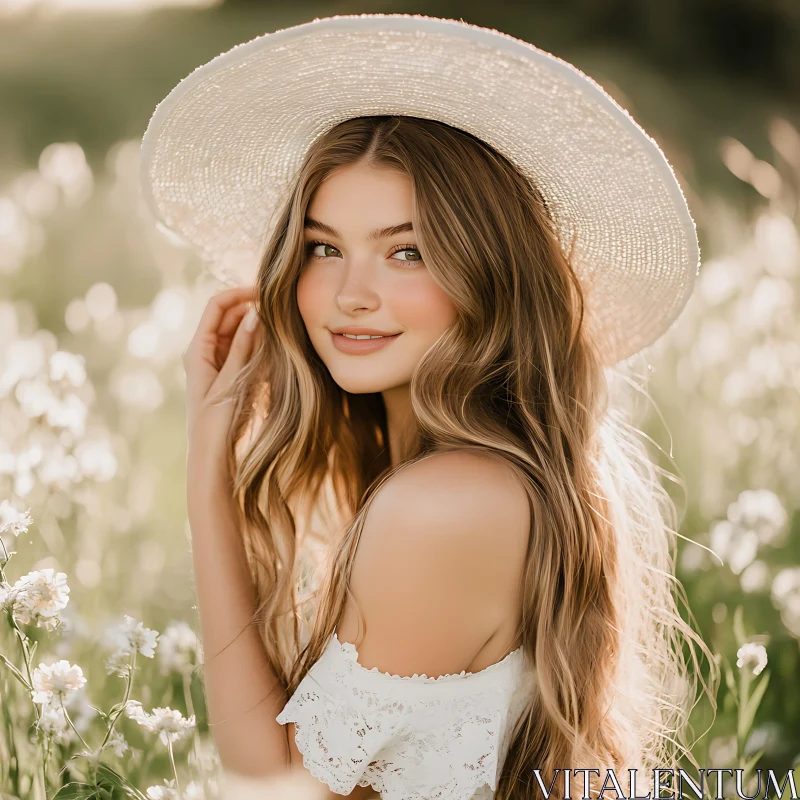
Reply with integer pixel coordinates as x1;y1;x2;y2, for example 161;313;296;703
183;287;300;776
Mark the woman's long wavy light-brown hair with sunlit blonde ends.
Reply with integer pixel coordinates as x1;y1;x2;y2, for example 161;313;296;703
220;116;716;800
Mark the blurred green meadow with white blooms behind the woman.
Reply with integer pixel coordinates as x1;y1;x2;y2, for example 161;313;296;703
0;0;800;796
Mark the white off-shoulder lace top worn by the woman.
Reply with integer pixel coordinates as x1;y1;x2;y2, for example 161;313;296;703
276;633;525;800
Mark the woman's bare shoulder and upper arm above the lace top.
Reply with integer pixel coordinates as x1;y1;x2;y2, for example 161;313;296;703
340;451;530;676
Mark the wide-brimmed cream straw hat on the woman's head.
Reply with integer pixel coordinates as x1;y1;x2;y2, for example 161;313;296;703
141;14;699;364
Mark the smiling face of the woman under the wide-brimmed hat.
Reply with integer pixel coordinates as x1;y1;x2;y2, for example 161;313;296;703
297;164;455;394
